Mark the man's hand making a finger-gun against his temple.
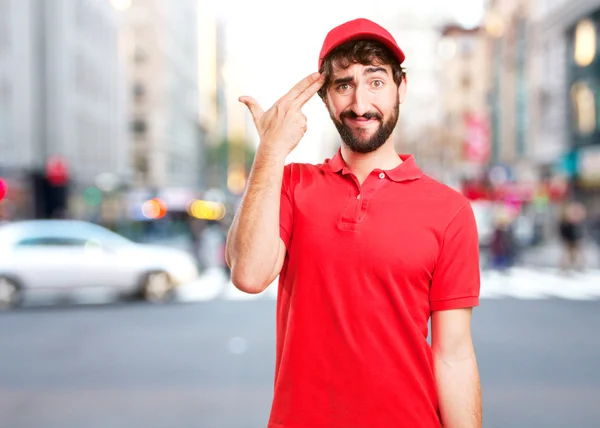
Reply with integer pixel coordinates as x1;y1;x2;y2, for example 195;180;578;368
239;73;325;158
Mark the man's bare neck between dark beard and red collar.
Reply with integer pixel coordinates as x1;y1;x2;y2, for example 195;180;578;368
341;138;402;182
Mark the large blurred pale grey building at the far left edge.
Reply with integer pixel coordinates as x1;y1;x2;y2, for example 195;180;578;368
0;0;128;216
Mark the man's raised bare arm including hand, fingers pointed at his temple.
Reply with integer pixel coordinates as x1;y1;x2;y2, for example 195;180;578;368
225;73;324;293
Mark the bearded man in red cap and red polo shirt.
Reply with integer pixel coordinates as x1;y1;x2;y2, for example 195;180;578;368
227;19;481;428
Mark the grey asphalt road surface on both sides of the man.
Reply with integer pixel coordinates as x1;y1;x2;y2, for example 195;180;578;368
0;299;600;428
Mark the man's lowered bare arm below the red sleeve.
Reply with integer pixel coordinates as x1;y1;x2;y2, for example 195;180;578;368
431;309;482;428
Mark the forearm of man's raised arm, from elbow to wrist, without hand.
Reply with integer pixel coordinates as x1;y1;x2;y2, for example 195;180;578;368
226;146;285;292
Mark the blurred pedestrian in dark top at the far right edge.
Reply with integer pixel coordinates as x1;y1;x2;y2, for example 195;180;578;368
559;202;586;272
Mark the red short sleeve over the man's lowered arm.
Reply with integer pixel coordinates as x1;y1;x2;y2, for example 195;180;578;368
429;203;480;311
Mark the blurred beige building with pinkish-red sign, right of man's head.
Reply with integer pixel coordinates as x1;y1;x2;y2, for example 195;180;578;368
432;24;491;184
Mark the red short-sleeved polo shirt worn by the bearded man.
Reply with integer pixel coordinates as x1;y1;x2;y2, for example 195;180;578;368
269;151;479;428
